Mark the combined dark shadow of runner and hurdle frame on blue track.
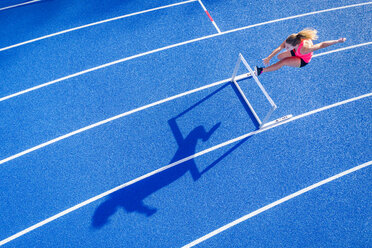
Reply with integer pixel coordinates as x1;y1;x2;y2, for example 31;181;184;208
91;84;251;229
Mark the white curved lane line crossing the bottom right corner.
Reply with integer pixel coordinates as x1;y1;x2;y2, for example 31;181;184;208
182;161;372;248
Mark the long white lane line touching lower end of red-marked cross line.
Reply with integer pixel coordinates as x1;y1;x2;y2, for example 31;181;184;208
0;2;372;102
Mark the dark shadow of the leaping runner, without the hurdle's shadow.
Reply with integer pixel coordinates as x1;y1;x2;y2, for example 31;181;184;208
92;120;220;228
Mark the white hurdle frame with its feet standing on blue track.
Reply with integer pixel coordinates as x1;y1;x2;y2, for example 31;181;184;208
231;53;292;128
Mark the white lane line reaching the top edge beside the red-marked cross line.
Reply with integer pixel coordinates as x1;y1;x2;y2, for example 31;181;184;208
0;0;197;52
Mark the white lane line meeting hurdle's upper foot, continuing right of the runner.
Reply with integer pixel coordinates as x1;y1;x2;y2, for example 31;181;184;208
0;42;371;165
